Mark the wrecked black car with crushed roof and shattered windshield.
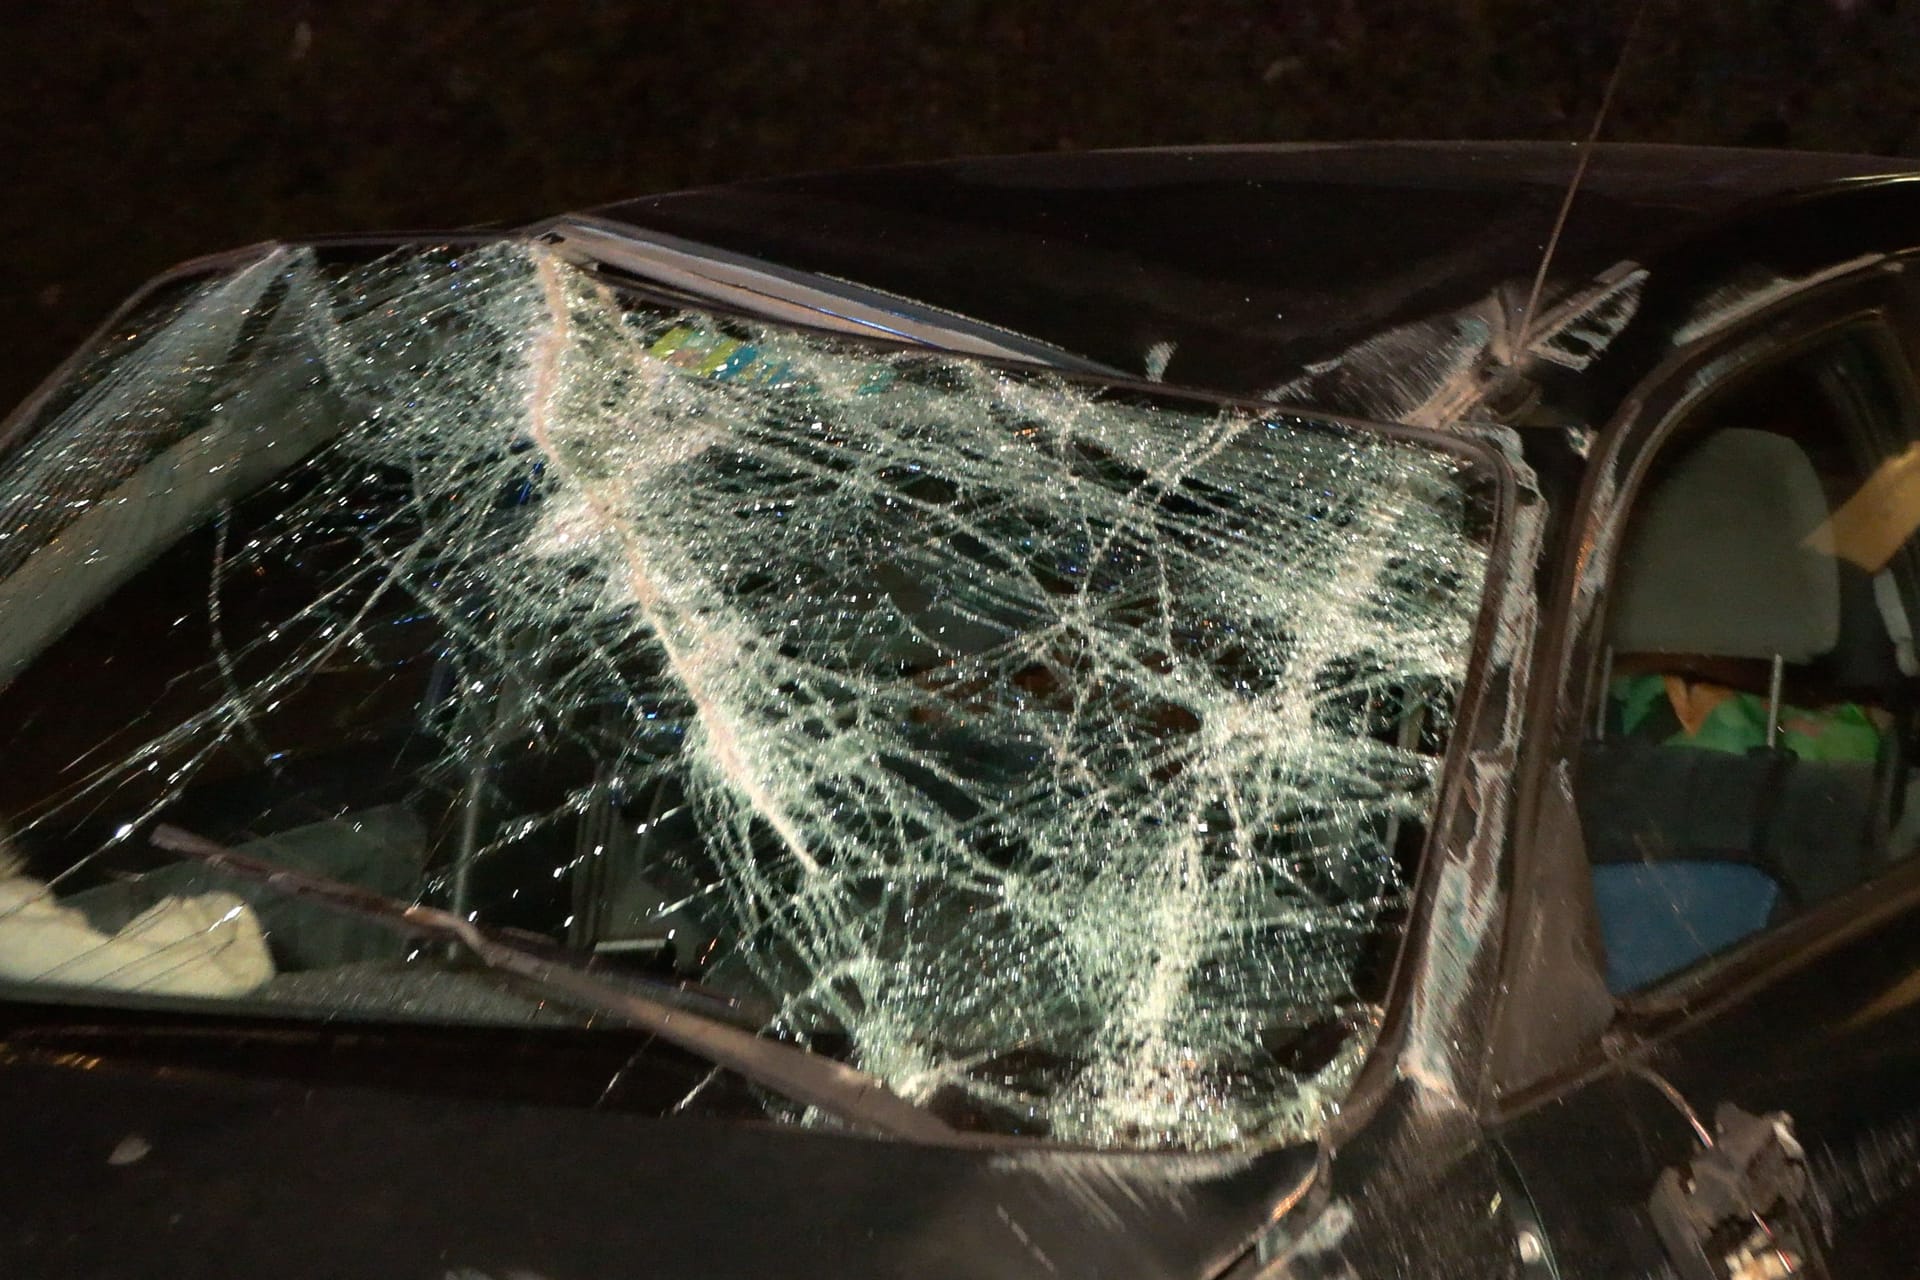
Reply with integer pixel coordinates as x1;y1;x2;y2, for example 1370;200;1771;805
0;144;1920;1280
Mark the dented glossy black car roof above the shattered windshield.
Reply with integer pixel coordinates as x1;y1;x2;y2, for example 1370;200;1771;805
595;142;1914;393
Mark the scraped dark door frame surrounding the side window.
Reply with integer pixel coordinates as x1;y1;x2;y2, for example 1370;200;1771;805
1484;257;1920;1280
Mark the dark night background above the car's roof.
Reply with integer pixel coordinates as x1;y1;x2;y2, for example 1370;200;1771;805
0;0;1920;403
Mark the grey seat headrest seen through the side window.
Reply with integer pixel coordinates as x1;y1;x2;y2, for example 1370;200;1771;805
1607;428;1839;662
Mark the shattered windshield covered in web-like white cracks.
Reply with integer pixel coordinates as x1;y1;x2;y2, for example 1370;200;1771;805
0;242;1490;1148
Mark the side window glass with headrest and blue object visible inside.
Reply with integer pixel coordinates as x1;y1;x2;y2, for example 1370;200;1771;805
1578;328;1920;994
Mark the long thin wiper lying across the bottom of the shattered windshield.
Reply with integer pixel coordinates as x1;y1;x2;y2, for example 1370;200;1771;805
148;823;968;1144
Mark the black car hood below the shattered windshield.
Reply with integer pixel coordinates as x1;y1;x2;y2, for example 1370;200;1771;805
0;1059;1315;1280
